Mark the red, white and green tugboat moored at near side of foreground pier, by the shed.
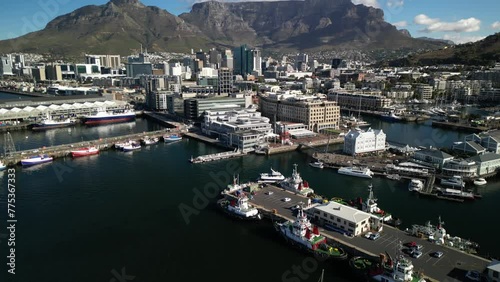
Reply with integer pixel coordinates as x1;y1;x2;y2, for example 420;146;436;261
274;208;347;260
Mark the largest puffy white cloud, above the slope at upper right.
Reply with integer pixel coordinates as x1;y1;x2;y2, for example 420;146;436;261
413;14;481;33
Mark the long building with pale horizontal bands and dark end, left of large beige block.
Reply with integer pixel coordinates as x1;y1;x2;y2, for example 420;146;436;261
184;98;247;120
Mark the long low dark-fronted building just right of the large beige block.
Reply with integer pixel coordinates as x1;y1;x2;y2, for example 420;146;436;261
328;89;392;111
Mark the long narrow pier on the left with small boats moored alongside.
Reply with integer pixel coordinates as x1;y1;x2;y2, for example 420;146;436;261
3;129;182;166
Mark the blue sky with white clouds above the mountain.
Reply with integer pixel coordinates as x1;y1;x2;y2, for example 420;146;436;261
0;0;500;43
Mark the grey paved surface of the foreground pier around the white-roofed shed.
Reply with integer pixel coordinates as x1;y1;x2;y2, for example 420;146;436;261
242;185;491;281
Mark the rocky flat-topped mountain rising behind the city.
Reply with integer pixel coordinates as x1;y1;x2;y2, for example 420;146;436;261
0;0;442;55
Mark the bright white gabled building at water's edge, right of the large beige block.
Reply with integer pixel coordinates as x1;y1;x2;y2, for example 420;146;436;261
344;128;386;156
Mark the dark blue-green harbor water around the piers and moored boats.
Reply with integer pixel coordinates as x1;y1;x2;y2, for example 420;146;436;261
0;92;500;282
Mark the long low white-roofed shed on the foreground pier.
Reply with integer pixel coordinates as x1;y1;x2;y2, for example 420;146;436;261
304;201;382;236
